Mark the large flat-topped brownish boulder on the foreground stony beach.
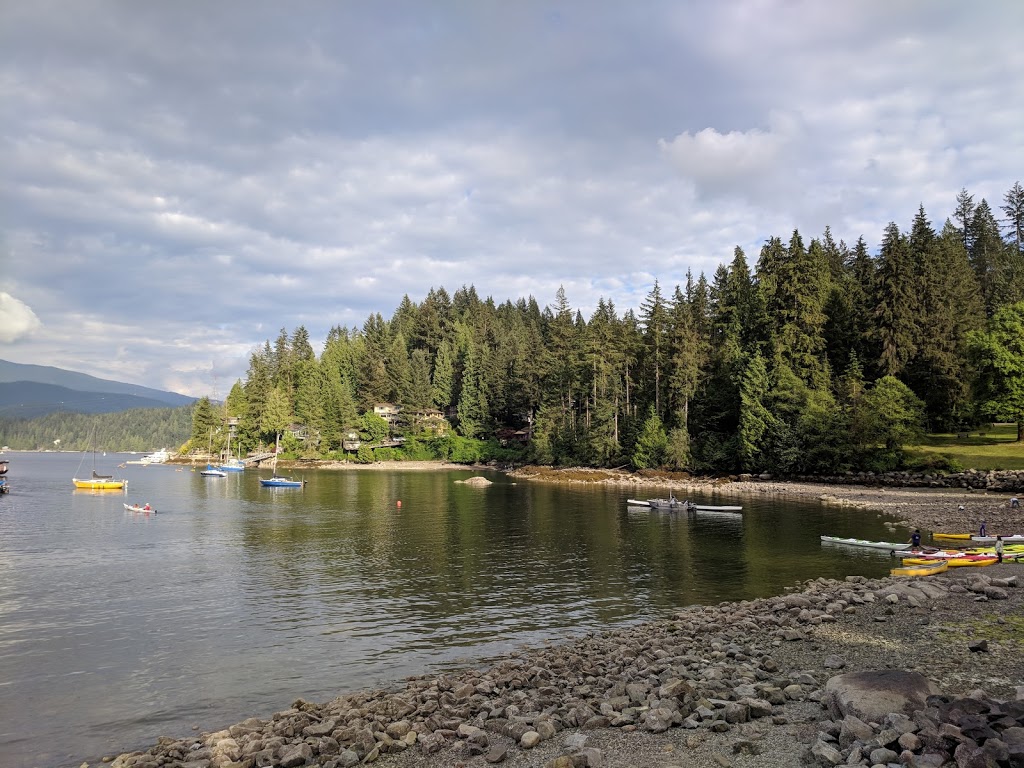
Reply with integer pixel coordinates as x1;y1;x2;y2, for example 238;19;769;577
824;670;941;723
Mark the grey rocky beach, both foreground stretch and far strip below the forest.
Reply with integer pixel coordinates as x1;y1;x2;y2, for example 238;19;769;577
92;469;1024;768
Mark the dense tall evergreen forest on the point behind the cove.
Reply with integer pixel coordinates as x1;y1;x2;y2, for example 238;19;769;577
2;182;1024;474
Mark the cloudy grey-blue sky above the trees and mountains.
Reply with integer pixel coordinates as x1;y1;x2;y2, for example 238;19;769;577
0;0;1024;397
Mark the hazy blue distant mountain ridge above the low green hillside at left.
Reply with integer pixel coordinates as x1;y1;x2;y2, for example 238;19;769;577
0;360;196;419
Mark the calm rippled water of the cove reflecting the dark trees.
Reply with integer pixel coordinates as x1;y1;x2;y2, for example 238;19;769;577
0;453;892;768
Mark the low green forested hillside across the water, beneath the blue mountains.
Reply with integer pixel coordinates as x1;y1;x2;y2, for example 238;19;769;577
0;406;193;453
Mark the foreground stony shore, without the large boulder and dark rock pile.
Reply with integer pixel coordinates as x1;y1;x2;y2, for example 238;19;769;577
97;563;1024;768
